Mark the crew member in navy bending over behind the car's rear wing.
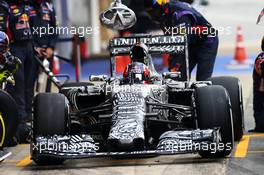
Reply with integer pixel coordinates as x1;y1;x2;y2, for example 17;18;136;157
144;0;219;81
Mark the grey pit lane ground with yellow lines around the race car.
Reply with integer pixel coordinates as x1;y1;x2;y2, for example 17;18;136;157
0;75;264;175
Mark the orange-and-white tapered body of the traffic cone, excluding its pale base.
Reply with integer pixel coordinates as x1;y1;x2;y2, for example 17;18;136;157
235;26;248;63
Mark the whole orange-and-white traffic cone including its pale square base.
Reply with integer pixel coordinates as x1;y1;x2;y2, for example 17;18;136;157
226;26;253;69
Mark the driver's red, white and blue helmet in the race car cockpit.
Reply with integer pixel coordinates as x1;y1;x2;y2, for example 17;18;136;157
123;62;150;84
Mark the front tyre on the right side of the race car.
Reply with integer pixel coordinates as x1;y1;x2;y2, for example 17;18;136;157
194;85;234;158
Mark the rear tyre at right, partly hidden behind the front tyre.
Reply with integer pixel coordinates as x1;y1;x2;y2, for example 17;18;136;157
208;77;245;141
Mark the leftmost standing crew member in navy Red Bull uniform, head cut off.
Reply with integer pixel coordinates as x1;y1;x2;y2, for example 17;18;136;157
1;0;35;143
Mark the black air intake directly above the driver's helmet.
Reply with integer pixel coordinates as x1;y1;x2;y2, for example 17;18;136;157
130;43;148;63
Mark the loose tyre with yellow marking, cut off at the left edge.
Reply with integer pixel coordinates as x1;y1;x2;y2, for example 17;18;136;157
0;90;19;147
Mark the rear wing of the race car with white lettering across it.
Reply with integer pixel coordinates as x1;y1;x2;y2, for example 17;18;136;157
109;34;189;77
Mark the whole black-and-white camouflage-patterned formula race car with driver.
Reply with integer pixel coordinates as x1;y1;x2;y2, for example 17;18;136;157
31;35;243;165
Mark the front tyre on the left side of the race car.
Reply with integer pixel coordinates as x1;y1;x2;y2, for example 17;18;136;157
32;93;70;165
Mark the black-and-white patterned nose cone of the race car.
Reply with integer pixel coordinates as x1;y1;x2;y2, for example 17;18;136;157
108;92;146;151
